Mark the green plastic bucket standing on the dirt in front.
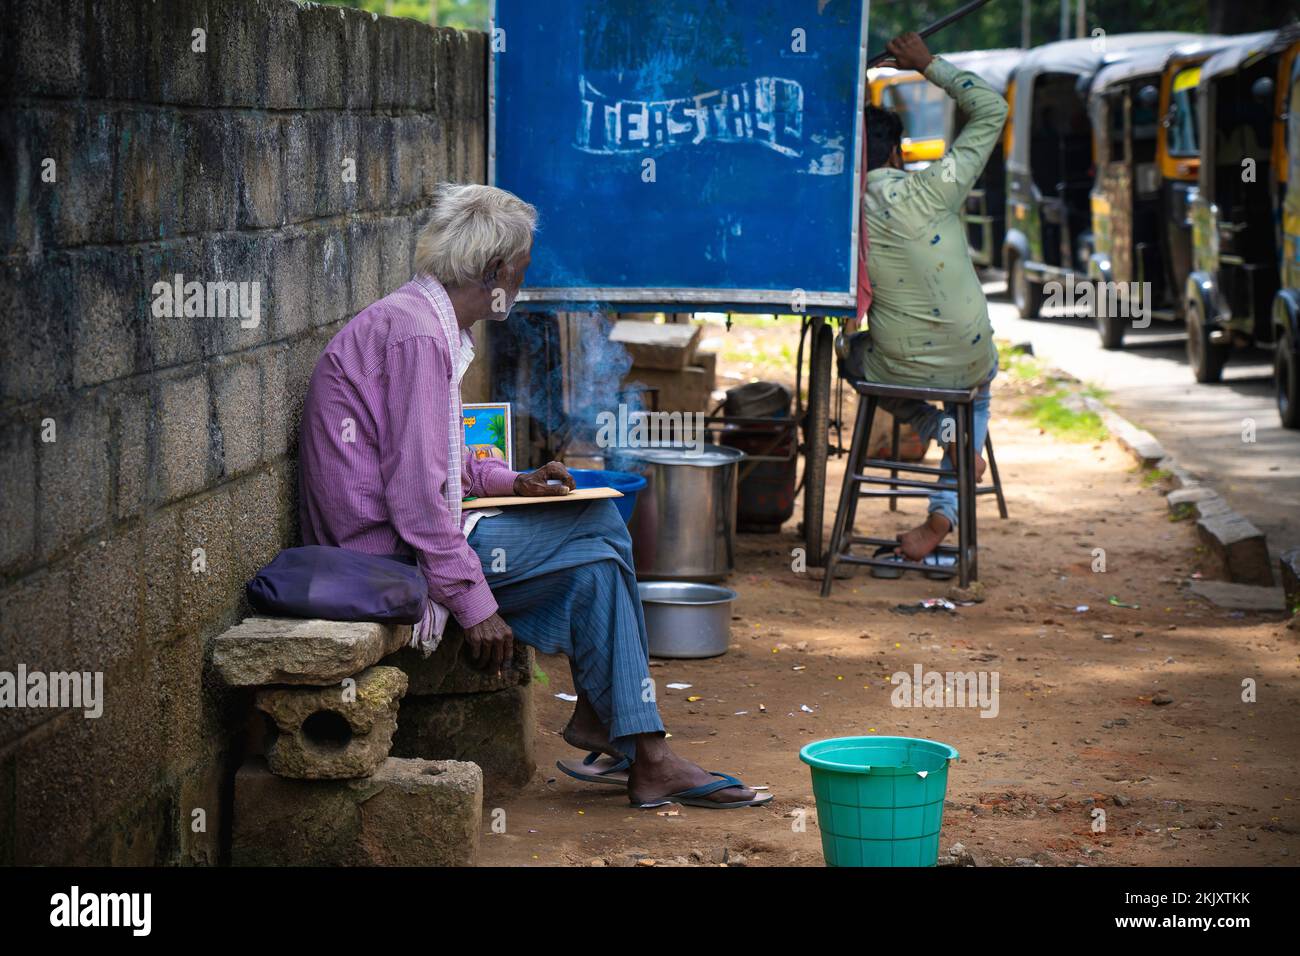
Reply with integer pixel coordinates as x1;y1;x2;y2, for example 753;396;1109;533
800;737;957;866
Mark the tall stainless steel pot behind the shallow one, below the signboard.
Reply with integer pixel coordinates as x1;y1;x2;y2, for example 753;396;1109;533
616;445;745;581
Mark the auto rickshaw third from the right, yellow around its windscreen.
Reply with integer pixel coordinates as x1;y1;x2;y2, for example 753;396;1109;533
1088;36;1229;349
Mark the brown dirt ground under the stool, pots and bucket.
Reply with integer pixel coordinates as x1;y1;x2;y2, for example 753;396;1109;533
481;316;1300;866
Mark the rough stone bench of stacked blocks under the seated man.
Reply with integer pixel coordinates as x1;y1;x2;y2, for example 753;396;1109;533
212;618;534;865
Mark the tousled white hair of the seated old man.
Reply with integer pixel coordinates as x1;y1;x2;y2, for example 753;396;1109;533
415;182;537;285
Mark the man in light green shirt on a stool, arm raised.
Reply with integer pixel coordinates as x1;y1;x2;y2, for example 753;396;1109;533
846;34;1006;561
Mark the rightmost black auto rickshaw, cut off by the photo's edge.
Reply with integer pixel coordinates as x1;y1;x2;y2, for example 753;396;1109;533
1273;34;1300;428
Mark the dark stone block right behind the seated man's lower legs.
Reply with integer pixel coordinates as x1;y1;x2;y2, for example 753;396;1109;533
393;685;537;795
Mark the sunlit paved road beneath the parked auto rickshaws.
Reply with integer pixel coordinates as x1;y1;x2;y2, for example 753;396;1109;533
984;282;1300;555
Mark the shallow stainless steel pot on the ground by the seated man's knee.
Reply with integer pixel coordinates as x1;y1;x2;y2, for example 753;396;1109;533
637;581;736;657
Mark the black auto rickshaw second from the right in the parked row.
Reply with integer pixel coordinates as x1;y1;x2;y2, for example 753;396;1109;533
1184;27;1300;408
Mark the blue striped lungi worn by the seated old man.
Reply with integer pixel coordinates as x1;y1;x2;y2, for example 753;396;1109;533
469;499;663;757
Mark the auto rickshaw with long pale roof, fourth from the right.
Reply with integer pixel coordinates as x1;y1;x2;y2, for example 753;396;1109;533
1002;33;1196;319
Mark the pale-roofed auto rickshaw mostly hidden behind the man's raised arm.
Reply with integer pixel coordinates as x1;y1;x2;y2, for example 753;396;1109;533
943;49;1024;269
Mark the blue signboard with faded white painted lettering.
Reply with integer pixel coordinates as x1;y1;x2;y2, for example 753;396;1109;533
489;0;866;313
